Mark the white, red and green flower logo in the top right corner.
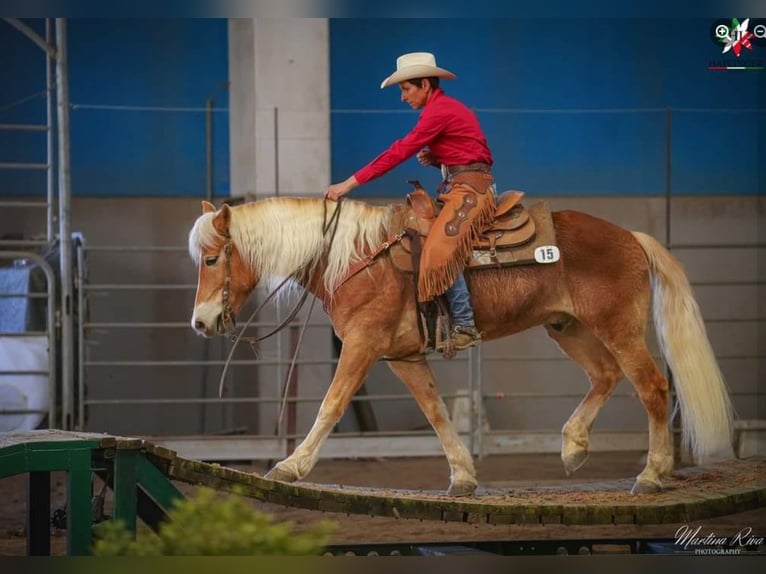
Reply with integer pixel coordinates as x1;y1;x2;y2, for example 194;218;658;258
708;18;766;70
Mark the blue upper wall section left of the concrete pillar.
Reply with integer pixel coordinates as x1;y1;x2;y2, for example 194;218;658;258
0;19;229;196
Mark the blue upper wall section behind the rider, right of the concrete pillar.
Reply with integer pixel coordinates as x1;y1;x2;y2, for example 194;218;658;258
330;19;766;195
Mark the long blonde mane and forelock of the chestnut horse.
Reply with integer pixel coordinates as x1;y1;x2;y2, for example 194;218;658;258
189;197;391;293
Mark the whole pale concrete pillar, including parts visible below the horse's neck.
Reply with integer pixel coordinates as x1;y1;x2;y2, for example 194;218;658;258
222;18;332;434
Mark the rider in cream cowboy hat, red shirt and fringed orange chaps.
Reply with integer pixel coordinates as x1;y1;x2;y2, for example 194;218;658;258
325;52;495;350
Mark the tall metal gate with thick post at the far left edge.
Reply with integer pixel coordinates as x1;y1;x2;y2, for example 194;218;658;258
0;18;75;428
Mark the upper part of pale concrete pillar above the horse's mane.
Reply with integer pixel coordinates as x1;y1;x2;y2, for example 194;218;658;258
229;18;330;197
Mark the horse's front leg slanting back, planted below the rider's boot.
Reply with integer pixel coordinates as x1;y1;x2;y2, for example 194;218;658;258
388;360;477;496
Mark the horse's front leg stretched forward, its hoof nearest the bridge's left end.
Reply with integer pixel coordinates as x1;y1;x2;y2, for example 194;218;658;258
265;339;379;482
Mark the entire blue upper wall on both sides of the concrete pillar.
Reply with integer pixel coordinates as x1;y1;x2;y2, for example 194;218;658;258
0;19;766;196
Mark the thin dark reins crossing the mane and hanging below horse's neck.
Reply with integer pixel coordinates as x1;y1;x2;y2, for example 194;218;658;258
218;197;343;410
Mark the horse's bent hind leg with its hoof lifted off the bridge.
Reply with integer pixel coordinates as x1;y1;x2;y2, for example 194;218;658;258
546;319;623;475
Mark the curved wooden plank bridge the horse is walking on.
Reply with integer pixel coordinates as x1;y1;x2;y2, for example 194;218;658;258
13;430;752;524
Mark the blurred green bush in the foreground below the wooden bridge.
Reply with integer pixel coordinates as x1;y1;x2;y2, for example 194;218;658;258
93;488;336;556
